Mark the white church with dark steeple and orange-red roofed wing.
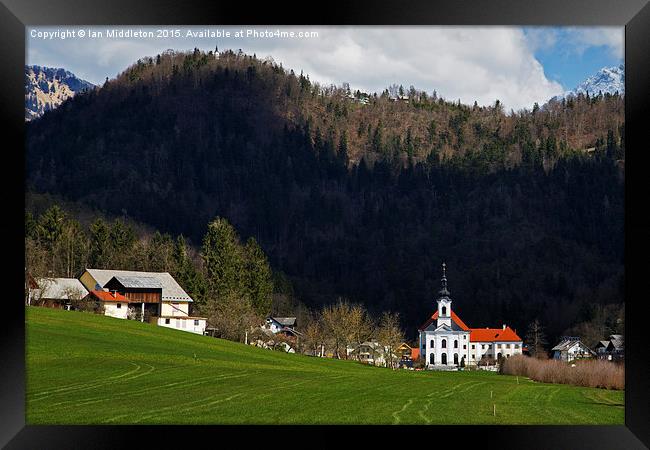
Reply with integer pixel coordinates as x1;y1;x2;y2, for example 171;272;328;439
418;263;523;370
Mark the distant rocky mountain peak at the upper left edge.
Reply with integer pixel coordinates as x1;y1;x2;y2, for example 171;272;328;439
25;66;95;121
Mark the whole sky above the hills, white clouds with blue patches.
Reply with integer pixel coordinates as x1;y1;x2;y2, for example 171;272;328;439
26;26;624;110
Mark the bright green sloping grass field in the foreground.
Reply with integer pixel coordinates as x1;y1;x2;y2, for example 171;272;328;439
26;307;624;424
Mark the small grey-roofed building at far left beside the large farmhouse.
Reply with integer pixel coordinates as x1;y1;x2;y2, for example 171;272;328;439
27;276;88;309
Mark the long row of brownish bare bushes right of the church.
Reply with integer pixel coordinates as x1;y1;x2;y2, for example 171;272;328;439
500;355;625;389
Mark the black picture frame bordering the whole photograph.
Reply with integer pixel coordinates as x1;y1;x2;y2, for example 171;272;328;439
0;0;650;449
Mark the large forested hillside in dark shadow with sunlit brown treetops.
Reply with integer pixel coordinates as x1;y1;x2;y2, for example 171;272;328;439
26;50;625;337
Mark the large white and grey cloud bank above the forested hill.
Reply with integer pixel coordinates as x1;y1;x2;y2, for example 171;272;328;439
28;26;564;110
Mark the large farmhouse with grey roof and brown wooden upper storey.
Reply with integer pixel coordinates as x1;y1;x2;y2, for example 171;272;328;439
79;269;206;334
